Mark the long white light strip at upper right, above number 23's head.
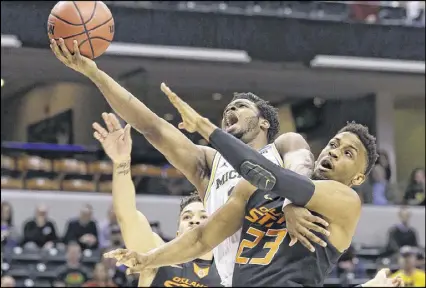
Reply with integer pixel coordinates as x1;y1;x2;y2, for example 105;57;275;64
310;55;425;74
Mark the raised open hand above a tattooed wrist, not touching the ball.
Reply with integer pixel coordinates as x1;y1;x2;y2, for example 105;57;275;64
93;113;132;163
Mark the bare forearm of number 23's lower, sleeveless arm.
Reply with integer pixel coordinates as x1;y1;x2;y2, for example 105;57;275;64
148;227;210;268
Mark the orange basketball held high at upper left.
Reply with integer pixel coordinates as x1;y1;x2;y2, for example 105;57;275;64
47;1;114;59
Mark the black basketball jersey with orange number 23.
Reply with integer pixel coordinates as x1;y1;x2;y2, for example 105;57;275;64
232;190;341;287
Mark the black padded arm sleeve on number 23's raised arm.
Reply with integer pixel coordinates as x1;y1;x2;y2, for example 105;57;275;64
209;129;315;206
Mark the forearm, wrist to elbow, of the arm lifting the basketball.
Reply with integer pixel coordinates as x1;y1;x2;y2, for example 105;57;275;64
86;69;162;134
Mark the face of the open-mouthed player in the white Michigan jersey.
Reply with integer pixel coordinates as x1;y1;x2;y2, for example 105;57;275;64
222;99;269;143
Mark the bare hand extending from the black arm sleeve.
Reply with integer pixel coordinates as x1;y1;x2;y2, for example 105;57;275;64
161;83;203;133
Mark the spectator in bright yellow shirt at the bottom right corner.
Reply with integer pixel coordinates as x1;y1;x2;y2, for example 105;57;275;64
392;246;425;287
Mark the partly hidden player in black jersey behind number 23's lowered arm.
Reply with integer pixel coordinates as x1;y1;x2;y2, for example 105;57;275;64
93;113;221;287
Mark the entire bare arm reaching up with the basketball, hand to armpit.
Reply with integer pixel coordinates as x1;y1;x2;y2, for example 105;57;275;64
51;39;214;198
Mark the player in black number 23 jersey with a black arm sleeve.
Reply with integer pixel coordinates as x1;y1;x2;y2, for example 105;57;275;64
106;86;402;287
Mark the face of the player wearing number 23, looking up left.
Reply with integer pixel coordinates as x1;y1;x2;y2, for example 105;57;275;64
313;132;367;186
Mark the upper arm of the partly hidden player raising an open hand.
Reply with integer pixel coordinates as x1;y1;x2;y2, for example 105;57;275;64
119;211;160;253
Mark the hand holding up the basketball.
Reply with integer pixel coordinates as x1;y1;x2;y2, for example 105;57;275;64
50;38;98;76
